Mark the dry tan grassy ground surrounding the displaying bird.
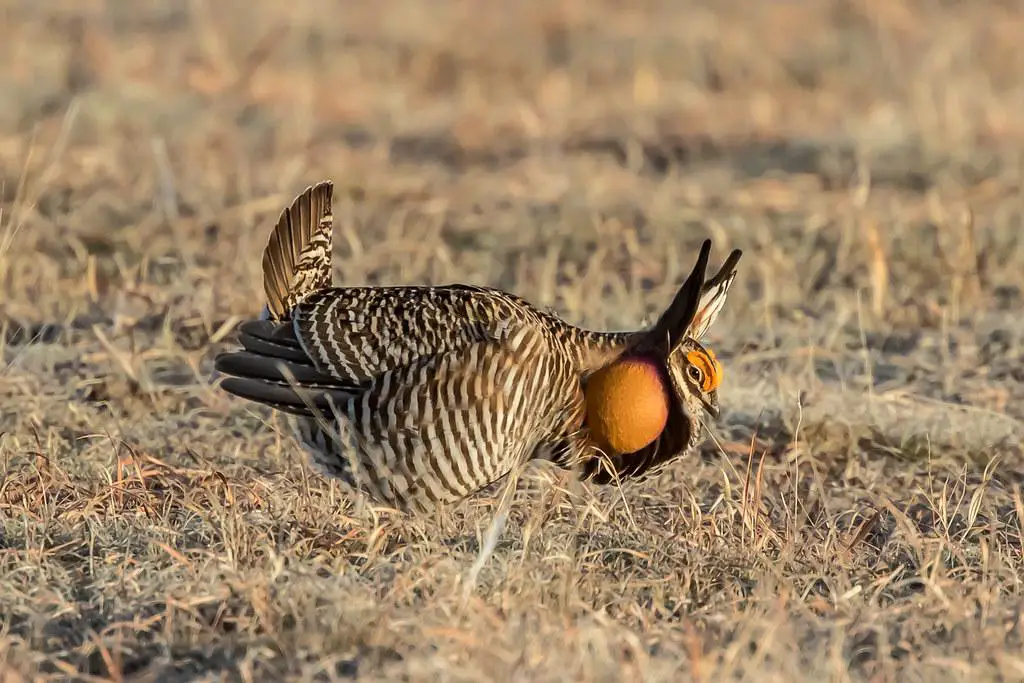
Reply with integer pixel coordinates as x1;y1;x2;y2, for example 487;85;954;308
0;0;1024;683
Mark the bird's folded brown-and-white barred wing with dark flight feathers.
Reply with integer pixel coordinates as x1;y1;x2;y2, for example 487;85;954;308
214;286;531;415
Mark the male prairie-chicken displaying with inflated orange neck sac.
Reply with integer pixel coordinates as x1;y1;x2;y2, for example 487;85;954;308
215;181;741;512
